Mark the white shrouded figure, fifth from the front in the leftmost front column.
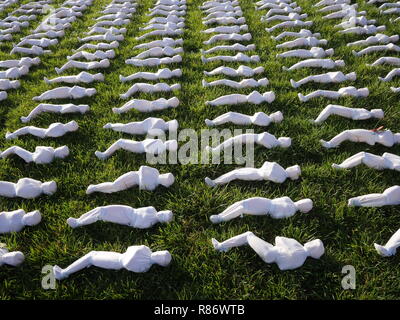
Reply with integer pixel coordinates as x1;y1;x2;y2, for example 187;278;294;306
6;121;79;139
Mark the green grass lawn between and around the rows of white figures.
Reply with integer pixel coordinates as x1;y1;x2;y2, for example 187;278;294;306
0;0;400;299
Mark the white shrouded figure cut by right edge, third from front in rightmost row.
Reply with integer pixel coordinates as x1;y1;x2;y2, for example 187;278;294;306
332;152;400;171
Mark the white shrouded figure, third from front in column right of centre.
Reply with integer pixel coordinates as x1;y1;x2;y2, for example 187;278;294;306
205;161;301;187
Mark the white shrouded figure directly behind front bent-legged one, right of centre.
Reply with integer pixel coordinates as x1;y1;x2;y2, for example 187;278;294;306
210;197;313;223
